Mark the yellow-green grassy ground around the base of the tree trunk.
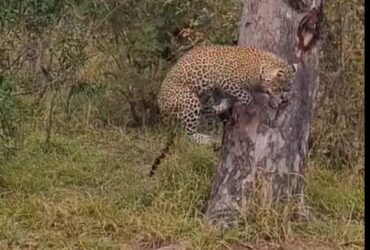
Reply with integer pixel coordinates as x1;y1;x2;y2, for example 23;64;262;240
0;125;364;249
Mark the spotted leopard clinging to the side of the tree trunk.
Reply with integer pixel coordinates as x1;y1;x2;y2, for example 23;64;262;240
150;45;298;178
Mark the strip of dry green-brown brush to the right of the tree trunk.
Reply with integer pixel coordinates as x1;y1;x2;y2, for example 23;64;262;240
311;0;365;167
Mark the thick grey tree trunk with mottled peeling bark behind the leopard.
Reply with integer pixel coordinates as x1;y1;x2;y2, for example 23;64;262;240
206;0;323;226
